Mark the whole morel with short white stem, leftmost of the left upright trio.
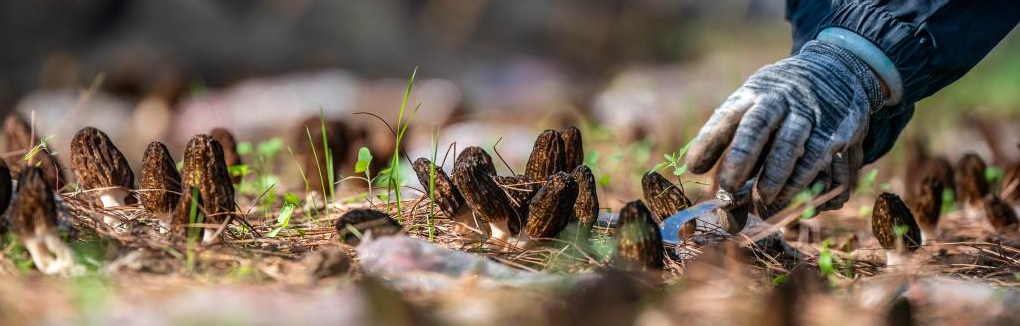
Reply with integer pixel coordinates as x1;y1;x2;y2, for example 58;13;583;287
70;126;135;226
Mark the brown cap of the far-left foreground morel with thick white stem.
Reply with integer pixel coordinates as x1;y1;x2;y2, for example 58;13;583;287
8;166;57;236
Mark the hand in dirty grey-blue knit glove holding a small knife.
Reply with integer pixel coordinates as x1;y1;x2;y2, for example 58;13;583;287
687;41;882;209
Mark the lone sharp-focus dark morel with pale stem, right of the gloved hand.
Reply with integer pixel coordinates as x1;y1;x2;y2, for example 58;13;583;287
871;193;921;266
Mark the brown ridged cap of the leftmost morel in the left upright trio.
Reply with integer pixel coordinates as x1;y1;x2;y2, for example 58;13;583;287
70;126;135;189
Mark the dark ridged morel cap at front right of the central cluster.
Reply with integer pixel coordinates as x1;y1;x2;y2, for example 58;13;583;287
525;172;577;237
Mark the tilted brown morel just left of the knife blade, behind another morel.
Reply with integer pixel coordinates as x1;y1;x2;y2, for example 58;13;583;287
641;171;698;238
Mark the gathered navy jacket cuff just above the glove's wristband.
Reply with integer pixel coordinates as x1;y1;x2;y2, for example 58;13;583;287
816;1;933;116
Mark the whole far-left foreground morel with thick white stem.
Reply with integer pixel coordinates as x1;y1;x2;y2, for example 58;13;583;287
8;166;74;275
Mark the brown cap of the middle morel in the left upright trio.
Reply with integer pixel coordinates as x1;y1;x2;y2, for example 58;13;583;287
139;142;181;214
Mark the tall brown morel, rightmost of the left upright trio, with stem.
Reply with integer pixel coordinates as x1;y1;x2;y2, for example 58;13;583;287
179;134;237;243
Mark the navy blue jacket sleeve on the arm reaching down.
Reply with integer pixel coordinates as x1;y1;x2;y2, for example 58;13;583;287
786;0;1020;163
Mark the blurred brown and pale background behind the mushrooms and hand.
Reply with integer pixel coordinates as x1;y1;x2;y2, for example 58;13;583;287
0;0;1020;201
